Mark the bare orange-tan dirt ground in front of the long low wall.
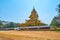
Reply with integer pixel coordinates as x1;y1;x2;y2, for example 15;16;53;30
0;31;60;40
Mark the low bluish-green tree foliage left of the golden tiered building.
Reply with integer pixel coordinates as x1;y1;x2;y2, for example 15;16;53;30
0;20;19;28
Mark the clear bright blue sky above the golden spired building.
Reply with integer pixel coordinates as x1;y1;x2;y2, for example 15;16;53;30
0;0;60;24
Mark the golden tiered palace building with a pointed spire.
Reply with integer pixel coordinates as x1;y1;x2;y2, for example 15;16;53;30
20;8;44;26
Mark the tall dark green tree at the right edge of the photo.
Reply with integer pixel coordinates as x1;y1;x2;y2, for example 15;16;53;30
50;4;60;28
